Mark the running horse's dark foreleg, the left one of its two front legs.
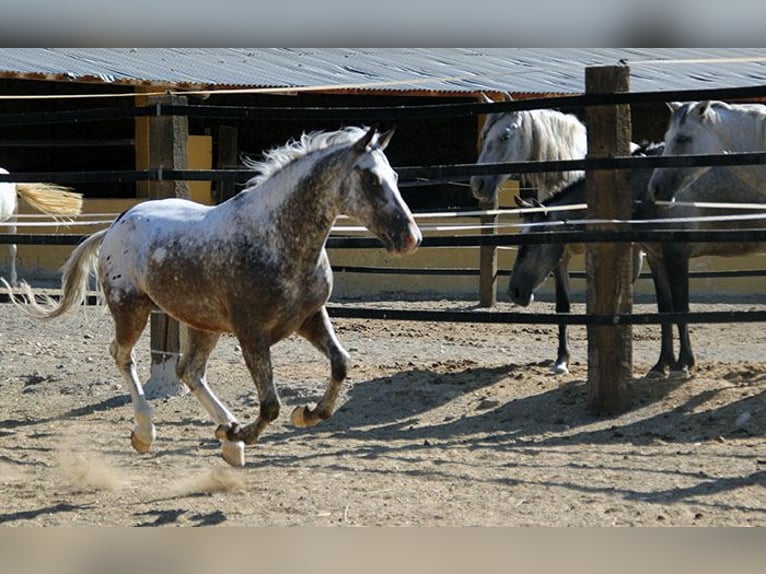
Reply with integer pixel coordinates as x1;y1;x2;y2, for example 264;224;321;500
222;333;280;450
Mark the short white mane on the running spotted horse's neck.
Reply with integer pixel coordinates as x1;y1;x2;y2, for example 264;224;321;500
242;126;367;188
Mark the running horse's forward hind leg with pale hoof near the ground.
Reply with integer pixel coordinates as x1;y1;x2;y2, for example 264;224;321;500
176;327;245;466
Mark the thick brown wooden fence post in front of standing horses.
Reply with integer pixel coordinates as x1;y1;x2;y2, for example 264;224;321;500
585;66;633;414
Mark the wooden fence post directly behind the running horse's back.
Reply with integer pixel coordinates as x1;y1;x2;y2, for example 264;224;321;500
144;96;189;398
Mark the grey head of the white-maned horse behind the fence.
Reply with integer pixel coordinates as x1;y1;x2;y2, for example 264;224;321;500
471;96;532;202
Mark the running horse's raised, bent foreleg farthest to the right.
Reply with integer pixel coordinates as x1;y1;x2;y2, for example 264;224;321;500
290;307;349;427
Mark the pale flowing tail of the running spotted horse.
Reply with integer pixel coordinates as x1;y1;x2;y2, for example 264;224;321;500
0;228;108;319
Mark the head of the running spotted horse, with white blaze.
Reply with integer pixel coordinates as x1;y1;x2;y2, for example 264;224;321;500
341;128;423;255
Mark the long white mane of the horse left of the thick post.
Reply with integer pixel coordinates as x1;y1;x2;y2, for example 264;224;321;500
522;110;588;194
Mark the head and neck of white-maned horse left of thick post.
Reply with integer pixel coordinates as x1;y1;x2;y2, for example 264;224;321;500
471;96;588;201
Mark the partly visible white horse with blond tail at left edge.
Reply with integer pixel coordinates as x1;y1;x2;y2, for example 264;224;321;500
0;167;82;285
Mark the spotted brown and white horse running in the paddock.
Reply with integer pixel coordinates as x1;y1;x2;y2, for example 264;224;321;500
4;127;421;466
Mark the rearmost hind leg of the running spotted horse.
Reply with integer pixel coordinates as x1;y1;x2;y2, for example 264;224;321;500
107;295;157;453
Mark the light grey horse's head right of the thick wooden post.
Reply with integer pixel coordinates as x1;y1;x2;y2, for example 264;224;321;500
649;101;731;201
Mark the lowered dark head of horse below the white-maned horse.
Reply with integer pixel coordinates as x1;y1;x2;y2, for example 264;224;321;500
508;197;565;307
